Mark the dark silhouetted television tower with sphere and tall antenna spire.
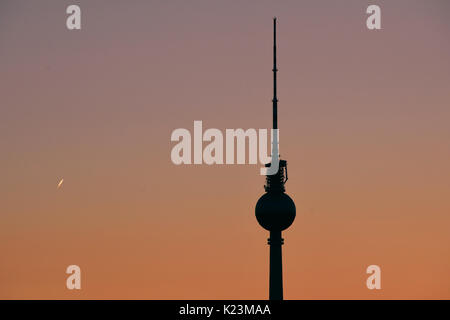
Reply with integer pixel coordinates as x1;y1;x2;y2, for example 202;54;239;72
255;17;295;300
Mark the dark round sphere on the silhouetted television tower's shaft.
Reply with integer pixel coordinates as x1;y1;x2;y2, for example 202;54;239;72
255;192;295;231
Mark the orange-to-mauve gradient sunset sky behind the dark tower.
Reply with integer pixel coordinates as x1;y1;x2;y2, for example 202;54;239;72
0;0;450;299
